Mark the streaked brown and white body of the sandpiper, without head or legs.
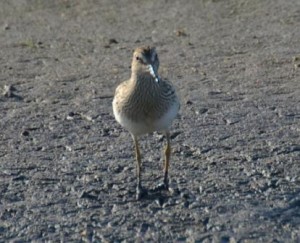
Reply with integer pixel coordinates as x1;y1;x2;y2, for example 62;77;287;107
113;46;180;135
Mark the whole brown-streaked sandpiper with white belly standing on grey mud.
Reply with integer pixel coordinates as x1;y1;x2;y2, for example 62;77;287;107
112;46;180;200
